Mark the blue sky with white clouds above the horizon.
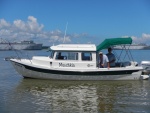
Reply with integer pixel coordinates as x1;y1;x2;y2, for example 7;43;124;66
0;0;150;46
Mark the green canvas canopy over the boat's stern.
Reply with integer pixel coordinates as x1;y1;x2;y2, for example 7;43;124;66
96;37;132;51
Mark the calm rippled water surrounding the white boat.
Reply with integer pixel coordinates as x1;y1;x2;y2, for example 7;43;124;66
0;50;150;113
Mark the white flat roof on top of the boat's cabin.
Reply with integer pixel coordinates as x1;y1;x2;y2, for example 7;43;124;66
50;44;96;51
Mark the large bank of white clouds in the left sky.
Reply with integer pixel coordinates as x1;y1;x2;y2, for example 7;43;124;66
0;16;94;45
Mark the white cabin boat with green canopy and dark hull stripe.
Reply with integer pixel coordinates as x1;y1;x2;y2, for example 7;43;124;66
10;37;143;80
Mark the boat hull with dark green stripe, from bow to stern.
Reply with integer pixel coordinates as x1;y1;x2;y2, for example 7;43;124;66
10;60;142;80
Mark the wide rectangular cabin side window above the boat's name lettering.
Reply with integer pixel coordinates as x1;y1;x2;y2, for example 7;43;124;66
56;52;78;60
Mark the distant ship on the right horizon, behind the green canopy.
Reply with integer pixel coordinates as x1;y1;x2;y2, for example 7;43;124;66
113;43;150;50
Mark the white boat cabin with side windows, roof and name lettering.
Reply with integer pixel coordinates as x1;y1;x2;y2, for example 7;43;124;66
47;44;97;69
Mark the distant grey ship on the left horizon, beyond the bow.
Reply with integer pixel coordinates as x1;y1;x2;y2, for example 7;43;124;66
0;40;42;50
